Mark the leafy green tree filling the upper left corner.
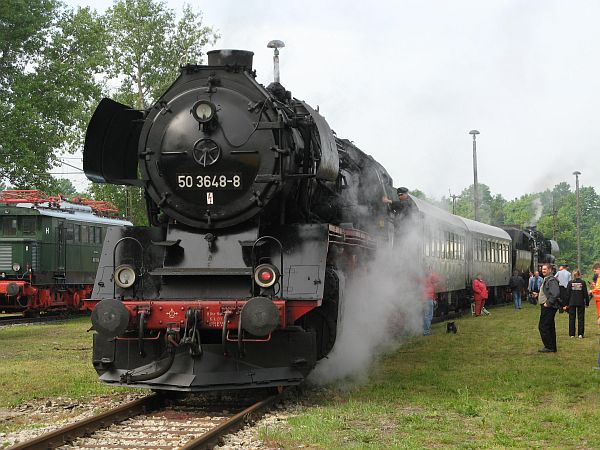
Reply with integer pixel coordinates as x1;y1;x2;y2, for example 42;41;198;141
0;0;105;189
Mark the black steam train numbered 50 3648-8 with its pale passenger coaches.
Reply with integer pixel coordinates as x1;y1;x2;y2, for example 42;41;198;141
84;50;556;391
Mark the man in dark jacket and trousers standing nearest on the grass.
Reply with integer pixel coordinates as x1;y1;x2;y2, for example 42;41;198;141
538;263;560;353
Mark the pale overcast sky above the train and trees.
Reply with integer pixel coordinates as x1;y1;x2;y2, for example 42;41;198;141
59;0;600;199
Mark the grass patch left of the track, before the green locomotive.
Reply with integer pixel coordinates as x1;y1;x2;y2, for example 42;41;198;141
0;317;132;436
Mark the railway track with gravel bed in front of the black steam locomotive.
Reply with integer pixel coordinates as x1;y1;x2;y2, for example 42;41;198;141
9;388;280;450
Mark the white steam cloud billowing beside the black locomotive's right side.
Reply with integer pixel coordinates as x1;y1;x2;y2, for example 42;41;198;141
310;216;425;383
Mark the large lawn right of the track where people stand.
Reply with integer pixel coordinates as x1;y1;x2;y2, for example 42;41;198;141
260;305;600;449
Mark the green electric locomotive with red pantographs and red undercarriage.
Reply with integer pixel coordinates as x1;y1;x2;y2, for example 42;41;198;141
0;190;131;315
